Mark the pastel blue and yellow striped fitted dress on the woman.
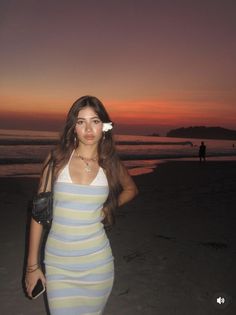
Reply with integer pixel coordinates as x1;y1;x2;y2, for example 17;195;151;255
45;168;114;315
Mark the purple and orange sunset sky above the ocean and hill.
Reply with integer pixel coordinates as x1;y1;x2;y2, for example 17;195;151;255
0;0;236;135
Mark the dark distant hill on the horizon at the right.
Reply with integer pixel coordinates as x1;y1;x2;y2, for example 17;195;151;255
166;126;236;140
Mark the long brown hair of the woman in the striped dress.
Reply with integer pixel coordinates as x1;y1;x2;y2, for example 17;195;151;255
47;96;122;224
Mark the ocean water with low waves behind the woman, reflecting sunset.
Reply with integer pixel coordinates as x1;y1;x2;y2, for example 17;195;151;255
0;130;236;177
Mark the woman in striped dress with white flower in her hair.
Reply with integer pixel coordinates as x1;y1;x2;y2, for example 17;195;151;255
25;96;137;315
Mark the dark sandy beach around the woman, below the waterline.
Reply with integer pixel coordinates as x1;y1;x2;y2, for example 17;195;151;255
0;161;236;315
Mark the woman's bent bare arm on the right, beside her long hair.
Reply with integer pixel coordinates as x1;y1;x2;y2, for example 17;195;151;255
118;164;138;206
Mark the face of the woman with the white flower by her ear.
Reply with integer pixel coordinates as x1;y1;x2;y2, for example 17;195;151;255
75;106;103;145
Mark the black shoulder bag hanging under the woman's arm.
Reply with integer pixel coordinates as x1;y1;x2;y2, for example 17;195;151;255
32;158;54;227
